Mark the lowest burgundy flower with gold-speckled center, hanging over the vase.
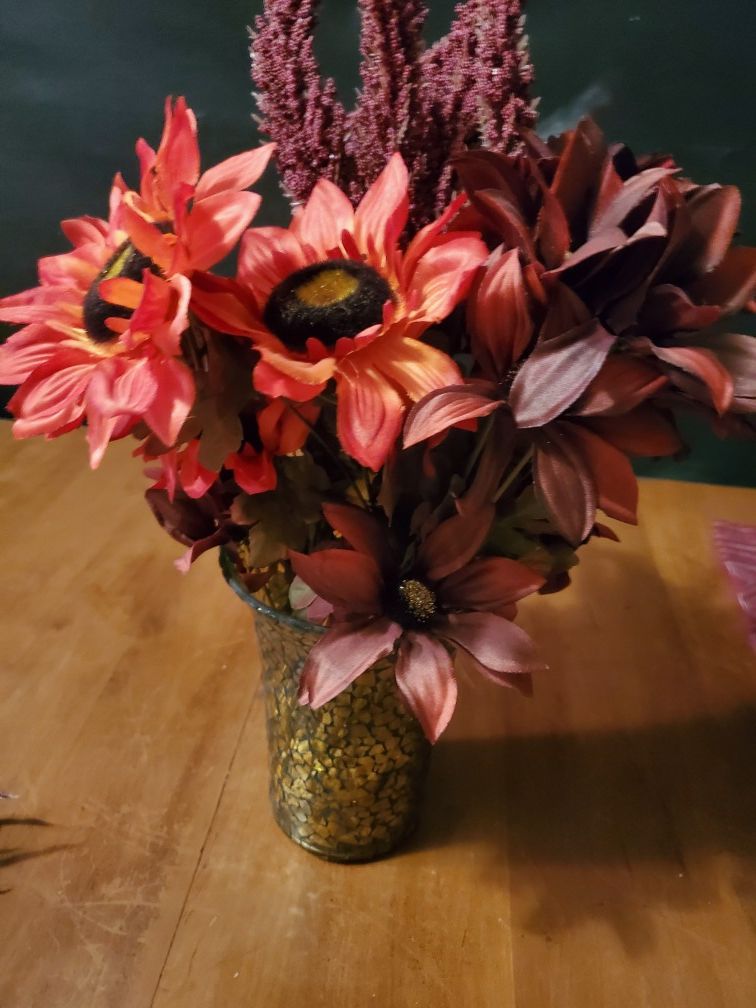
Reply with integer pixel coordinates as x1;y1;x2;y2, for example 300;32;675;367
289;504;543;742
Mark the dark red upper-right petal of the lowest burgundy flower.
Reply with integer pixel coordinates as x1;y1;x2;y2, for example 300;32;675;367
436;556;544;612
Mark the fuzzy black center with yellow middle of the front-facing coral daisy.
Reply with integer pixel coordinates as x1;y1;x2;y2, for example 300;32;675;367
263;259;393;350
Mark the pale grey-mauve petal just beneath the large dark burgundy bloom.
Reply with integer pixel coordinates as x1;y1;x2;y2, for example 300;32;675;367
509;319;615;427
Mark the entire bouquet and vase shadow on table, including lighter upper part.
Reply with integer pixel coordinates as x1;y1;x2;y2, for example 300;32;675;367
407;544;756;955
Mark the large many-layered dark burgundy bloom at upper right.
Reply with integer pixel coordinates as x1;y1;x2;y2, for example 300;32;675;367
458;120;756;415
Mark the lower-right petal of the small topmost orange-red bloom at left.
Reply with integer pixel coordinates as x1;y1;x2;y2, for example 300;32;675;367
181;193;261;269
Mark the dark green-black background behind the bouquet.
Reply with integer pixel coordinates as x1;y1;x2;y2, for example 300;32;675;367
0;0;756;485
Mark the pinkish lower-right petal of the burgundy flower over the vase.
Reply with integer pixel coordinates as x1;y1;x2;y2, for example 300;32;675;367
436;613;545;674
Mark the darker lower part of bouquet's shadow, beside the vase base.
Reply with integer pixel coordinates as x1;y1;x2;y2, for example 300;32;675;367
407;706;756;954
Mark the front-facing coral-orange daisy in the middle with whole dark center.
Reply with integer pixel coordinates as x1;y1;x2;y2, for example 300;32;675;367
193;154;487;470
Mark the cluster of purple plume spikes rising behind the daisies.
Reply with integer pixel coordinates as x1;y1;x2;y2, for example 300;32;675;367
252;0;535;231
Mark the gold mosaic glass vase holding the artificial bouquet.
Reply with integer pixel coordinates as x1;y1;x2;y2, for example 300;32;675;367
223;562;430;861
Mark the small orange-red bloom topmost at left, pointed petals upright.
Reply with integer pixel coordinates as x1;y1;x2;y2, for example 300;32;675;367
123;98;275;276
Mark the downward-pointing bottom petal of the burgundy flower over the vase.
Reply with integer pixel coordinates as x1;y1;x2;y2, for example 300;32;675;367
396;633;457;742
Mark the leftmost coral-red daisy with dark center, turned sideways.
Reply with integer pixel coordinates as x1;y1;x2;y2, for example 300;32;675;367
0;181;195;468
